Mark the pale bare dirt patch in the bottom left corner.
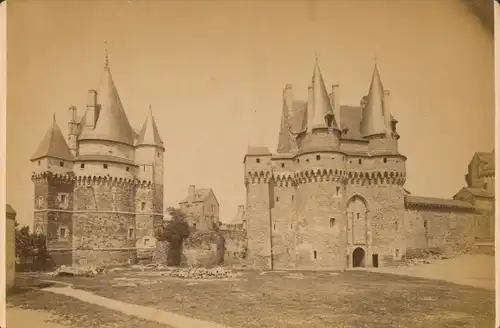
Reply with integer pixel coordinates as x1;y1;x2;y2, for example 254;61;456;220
7;307;72;328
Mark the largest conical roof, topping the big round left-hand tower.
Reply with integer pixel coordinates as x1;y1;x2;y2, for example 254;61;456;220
79;44;135;145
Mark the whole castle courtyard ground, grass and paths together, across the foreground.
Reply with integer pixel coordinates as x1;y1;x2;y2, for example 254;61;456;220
8;255;494;328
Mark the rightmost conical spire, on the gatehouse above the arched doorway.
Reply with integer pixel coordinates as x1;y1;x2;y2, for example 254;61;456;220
361;62;386;137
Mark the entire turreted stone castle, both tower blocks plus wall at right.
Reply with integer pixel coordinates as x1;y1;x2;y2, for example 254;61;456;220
31;56;495;270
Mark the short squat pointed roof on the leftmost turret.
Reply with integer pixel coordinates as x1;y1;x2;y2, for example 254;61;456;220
31;114;73;161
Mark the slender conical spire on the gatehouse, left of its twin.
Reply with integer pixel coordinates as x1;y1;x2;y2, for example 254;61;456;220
310;56;338;129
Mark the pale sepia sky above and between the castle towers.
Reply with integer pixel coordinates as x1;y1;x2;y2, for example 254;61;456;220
7;0;494;224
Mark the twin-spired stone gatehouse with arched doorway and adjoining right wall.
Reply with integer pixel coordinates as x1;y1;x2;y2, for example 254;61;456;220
240;60;494;270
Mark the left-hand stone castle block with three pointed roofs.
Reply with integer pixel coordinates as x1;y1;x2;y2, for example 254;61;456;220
31;55;165;265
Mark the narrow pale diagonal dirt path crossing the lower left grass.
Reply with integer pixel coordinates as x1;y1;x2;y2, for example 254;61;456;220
42;287;228;328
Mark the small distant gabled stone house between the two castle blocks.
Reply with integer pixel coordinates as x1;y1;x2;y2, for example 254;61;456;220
179;185;219;231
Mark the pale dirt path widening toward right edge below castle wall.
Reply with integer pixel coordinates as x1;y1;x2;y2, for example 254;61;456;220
367;254;495;290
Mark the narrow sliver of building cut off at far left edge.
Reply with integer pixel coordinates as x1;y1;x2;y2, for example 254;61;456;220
5;204;16;290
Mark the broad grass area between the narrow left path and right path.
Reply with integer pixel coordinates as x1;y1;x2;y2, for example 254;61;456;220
47;271;494;328
